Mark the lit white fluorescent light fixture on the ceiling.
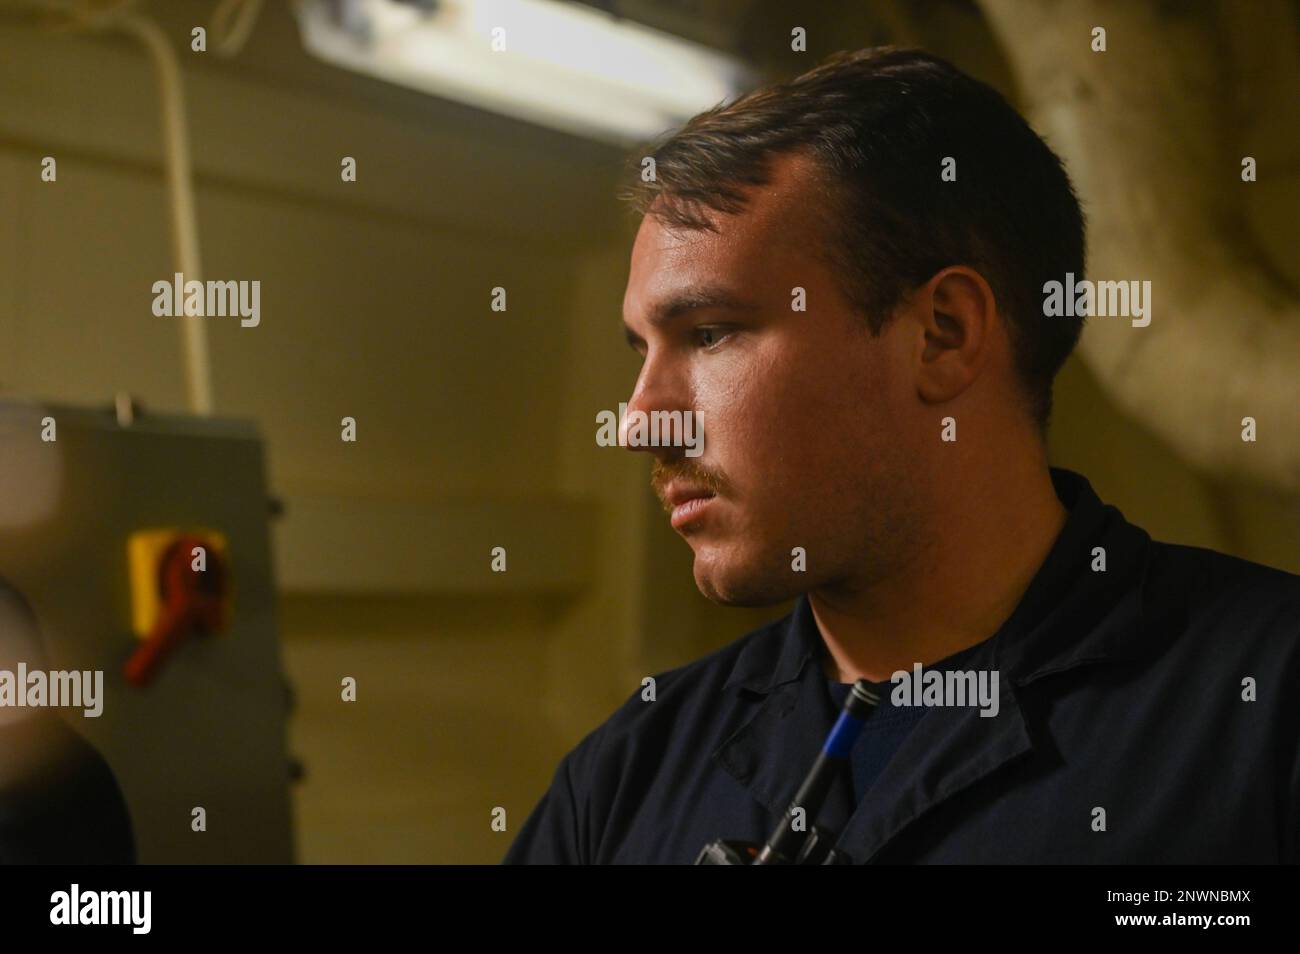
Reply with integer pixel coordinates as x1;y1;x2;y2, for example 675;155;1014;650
296;0;750;146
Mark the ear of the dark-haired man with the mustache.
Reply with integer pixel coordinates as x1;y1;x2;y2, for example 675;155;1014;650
911;265;997;404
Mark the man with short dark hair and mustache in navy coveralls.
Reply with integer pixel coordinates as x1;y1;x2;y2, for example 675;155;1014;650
506;44;1300;863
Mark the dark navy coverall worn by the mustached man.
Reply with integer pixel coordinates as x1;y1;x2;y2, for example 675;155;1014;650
504;468;1300;864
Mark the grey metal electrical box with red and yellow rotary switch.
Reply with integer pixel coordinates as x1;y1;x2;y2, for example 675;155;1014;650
0;399;294;864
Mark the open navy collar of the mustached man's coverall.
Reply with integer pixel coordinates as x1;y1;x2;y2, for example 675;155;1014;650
714;468;1178;863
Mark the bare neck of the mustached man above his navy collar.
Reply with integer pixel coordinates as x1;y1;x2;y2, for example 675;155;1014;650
809;459;1067;682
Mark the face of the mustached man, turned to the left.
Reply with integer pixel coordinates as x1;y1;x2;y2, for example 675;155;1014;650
623;156;917;606
